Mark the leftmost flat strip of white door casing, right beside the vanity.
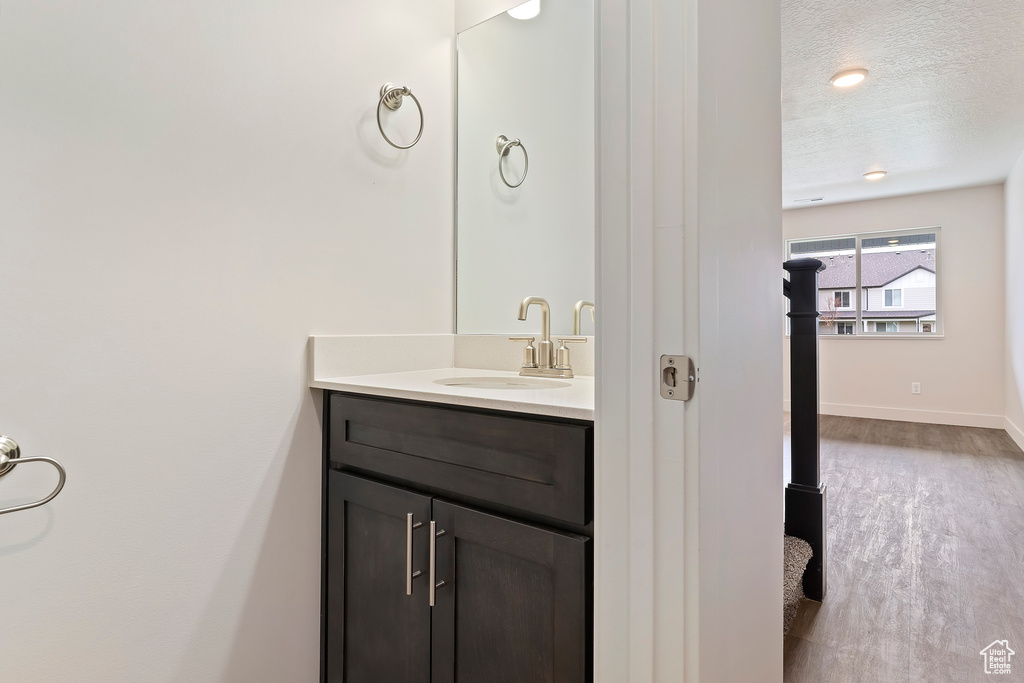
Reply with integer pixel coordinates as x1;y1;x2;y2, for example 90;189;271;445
594;0;632;683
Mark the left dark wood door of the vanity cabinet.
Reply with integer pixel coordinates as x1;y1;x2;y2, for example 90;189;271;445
326;471;430;683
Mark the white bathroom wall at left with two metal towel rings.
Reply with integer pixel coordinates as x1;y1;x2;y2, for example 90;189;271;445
0;0;454;681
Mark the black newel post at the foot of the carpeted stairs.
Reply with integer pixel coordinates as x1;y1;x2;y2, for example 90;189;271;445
782;258;827;600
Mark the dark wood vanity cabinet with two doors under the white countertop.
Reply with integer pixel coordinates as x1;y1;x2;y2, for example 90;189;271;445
323;393;593;683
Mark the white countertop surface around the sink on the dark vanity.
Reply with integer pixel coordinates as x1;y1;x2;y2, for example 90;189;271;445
309;368;594;420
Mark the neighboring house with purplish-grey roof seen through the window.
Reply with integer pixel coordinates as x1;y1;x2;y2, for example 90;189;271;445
817;248;936;335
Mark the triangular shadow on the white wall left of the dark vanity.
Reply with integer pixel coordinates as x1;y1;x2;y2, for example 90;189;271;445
172;388;323;681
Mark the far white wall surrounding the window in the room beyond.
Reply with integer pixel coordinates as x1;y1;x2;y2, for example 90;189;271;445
780;184;1005;427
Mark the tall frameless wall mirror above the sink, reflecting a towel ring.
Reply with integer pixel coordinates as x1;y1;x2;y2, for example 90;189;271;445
456;0;595;335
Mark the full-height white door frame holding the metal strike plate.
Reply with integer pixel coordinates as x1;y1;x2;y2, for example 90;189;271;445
594;0;782;683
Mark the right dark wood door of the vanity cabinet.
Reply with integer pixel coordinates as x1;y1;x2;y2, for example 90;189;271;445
431;499;591;683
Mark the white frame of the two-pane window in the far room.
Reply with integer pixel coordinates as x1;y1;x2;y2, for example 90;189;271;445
783;225;945;340
